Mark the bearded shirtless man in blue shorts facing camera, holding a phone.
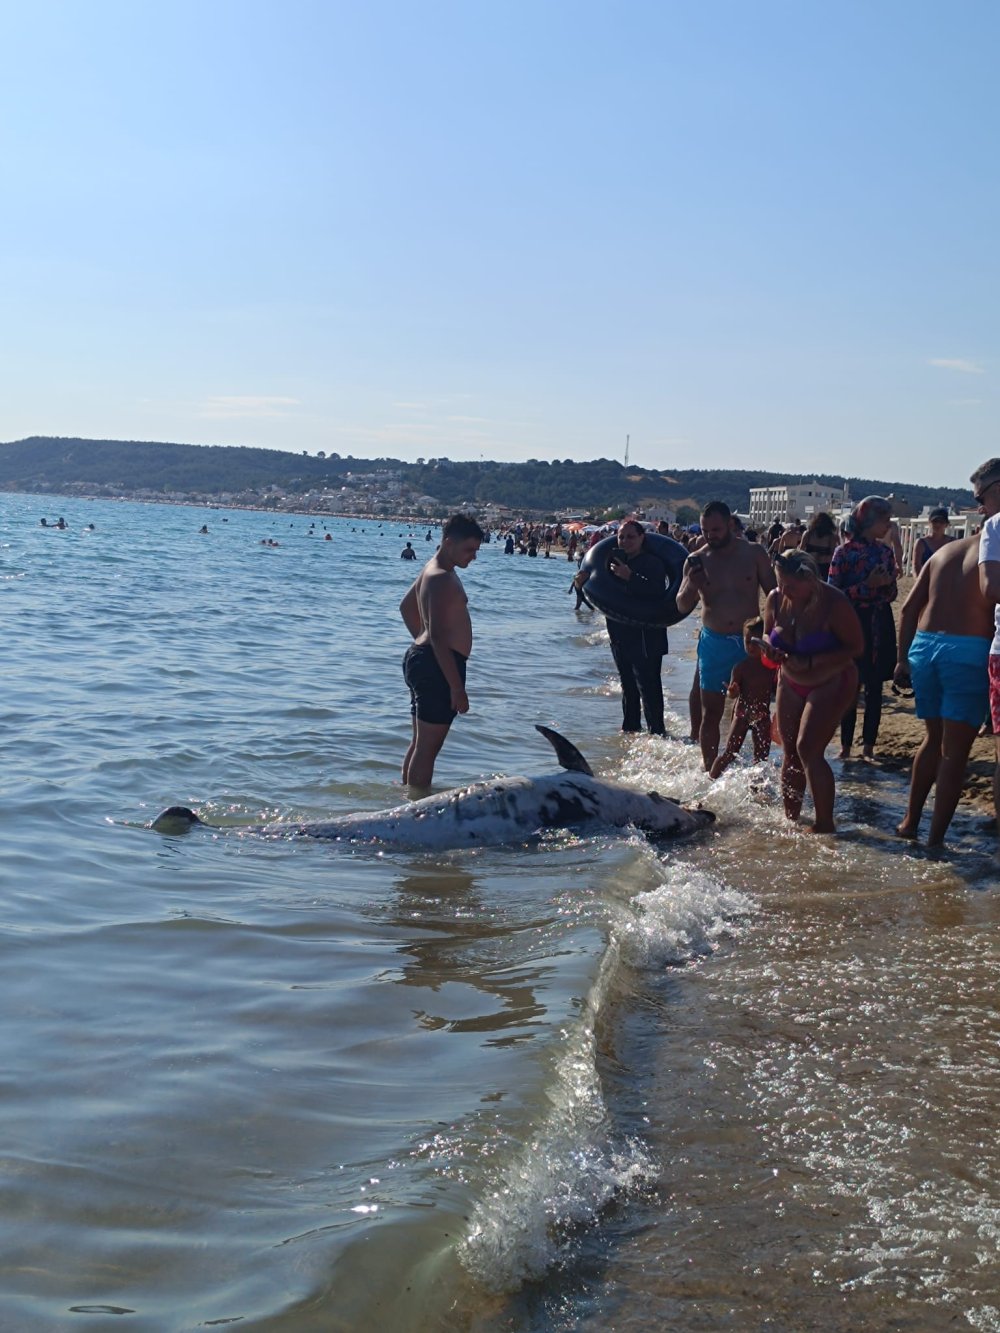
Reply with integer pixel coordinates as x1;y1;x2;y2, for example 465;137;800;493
677;500;776;769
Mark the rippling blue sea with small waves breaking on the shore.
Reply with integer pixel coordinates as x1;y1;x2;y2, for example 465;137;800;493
0;495;1000;1333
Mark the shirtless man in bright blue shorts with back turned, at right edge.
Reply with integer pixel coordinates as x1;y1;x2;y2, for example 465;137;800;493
893;535;993;846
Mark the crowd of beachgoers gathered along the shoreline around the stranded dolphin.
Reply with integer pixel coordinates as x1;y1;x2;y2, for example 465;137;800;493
400;459;1000;845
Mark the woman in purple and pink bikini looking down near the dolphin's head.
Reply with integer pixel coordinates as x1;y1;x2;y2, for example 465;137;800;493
764;551;864;833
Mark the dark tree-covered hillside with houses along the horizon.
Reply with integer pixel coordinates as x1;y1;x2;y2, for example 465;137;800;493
0;436;971;513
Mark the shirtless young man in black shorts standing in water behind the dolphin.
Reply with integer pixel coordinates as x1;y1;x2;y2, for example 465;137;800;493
399;513;483;789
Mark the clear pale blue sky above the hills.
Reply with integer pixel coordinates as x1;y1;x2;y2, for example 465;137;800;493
0;0;1000;485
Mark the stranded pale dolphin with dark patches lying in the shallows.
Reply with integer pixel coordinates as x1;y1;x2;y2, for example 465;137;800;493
152;726;715;849
